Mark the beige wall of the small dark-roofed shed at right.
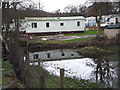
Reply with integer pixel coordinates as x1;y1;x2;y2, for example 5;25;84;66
104;29;120;39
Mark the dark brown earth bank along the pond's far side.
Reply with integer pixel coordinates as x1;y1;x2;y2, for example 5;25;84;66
23;39;118;52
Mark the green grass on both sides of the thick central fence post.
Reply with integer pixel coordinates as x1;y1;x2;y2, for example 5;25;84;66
45;69;99;88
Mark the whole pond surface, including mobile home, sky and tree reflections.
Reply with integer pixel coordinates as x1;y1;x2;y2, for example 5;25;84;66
29;49;118;88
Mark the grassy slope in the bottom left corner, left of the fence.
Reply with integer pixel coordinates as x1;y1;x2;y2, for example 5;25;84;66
1;61;24;88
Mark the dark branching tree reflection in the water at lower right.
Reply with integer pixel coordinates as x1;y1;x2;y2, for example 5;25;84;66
93;58;118;88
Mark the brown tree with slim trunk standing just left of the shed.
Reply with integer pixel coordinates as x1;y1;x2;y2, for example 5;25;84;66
87;0;117;39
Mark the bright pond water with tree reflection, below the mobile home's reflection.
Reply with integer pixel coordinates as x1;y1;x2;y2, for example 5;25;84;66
31;49;118;88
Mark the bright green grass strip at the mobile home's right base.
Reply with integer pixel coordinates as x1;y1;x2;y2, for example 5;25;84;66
64;30;104;36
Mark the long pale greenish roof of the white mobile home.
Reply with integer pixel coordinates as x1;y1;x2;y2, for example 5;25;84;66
25;16;85;21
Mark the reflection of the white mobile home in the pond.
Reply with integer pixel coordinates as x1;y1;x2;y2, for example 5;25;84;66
29;49;81;61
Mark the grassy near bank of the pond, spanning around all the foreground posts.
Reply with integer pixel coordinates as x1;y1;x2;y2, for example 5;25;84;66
31;66;100;88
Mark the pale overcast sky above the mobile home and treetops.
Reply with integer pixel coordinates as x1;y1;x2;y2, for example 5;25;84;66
33;0;86;12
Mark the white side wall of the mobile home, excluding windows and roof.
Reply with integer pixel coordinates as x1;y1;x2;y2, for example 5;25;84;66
26;20;85;33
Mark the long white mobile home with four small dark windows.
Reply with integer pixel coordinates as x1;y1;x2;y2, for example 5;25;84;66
25;16;85;34
